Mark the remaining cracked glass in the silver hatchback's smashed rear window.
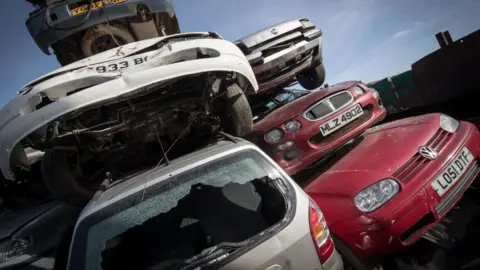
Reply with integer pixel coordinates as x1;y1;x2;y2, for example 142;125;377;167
69;150;284;269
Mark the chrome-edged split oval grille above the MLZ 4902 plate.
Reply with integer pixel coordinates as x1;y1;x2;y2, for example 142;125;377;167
304;91;353;121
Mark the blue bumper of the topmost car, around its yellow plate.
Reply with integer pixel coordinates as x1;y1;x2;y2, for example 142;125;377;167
26;0;175;55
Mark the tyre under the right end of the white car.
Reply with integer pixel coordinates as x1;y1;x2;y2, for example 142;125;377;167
222;84;253;137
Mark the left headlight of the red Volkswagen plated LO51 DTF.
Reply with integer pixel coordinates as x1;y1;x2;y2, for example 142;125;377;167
355;179;400;213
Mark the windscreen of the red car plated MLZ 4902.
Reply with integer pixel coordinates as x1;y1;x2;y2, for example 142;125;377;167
251;89;310;123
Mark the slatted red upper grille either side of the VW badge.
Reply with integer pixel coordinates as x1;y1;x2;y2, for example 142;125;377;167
393;129;453;184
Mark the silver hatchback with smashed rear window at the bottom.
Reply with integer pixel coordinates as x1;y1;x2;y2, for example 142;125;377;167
68;137;343;269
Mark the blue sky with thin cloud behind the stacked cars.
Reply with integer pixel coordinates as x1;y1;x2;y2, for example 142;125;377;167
0;0;480;104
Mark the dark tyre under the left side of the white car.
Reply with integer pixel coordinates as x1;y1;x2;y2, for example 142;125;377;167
42;149;95;206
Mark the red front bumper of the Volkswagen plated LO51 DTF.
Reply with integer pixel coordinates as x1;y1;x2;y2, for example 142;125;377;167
330;122;480;257
